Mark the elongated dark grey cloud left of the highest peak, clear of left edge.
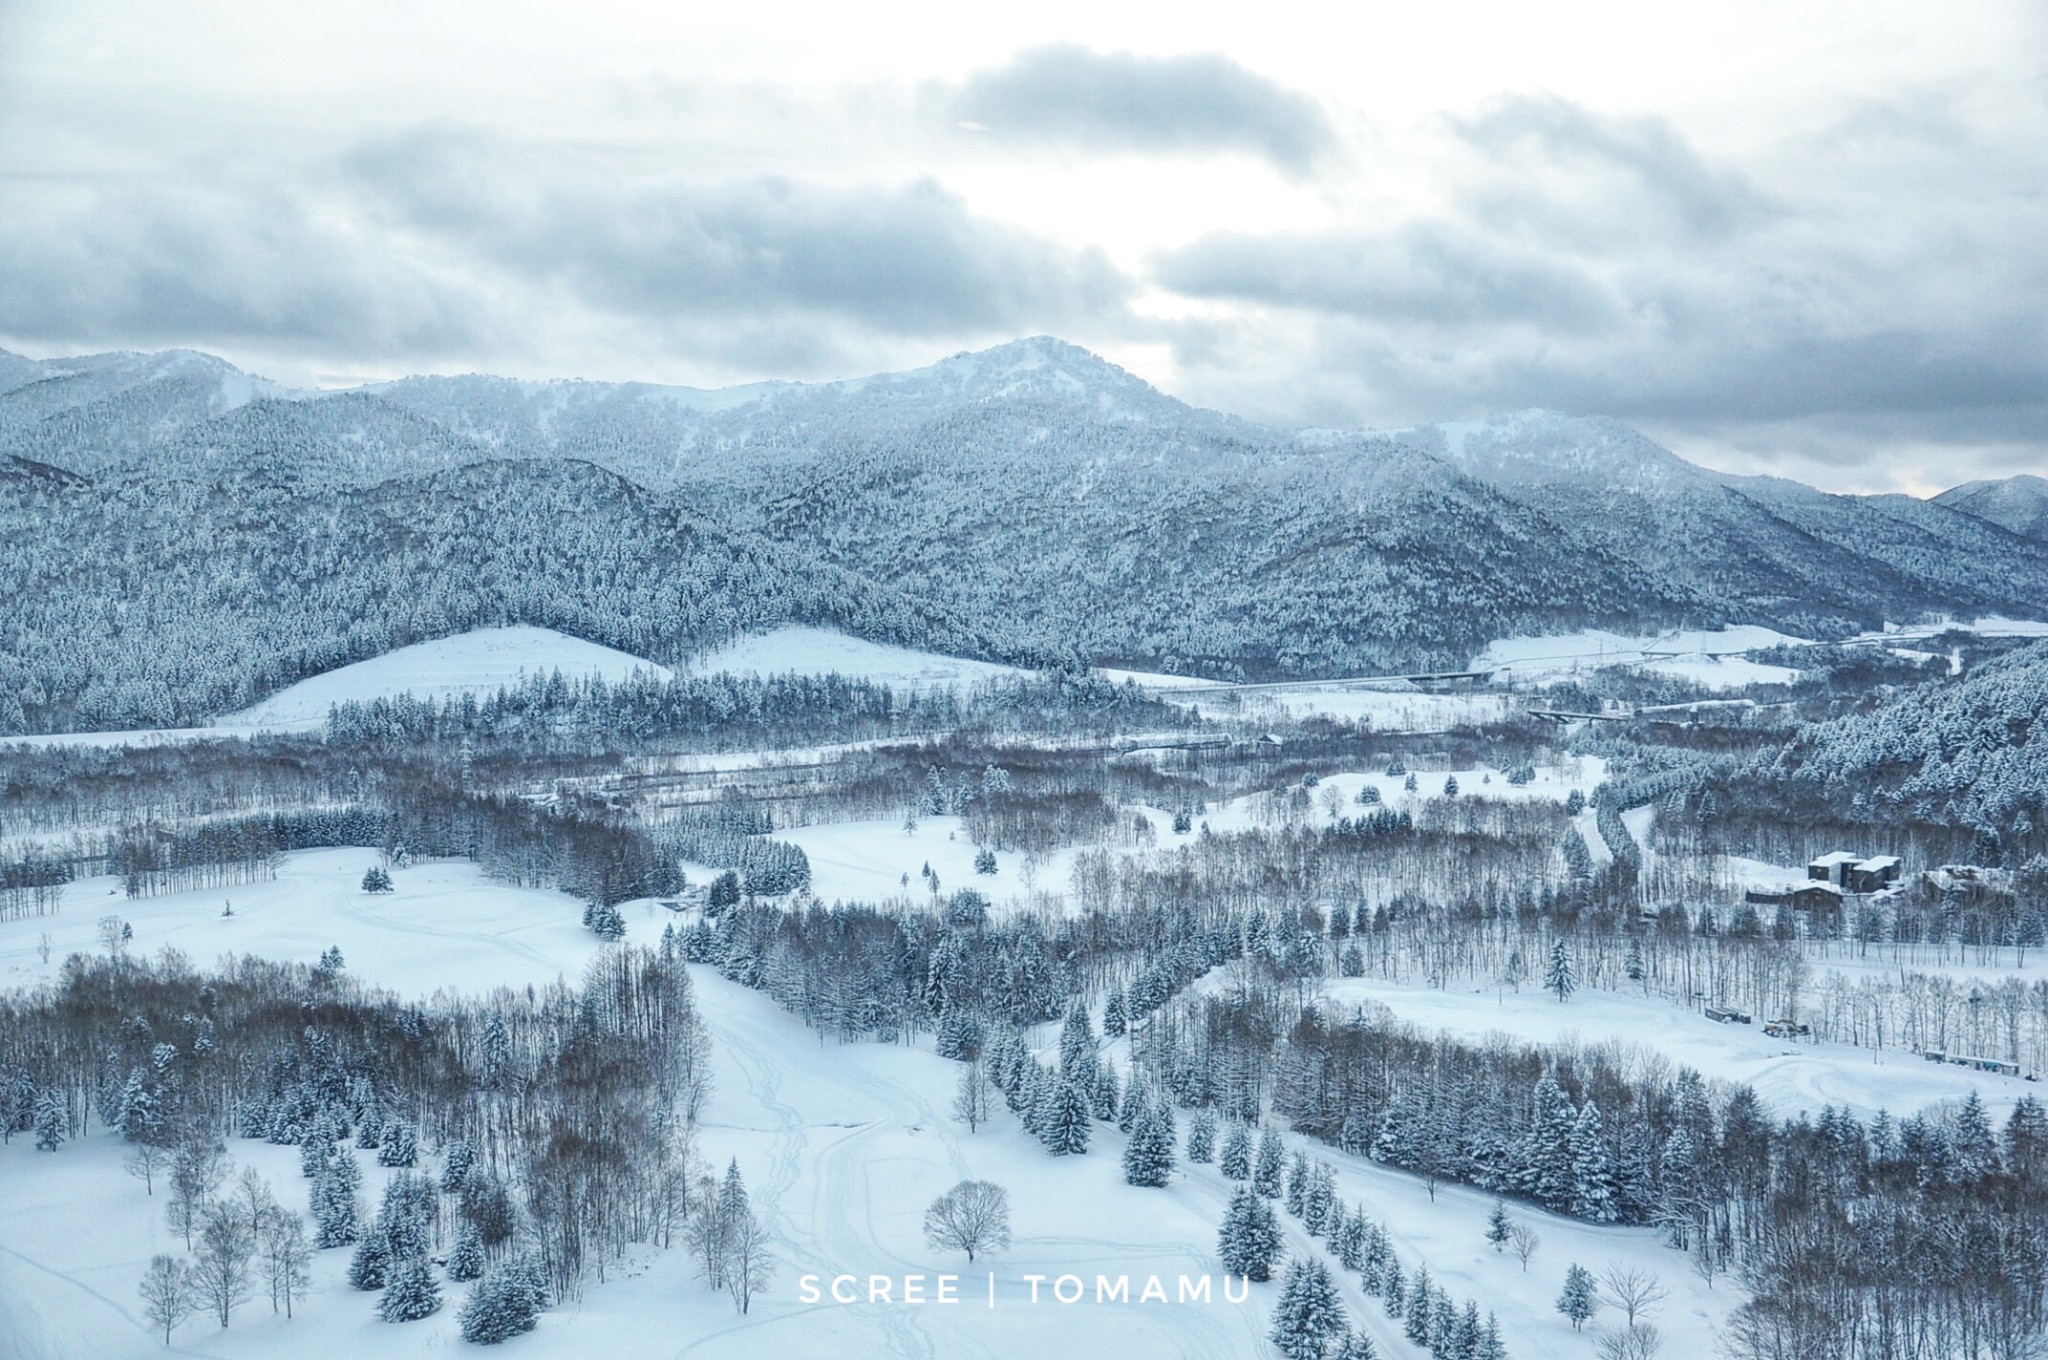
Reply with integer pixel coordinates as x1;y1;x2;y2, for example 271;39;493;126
350;131;1126;336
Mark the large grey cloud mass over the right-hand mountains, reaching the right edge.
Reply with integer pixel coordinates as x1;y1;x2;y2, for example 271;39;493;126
1153;96;2048;481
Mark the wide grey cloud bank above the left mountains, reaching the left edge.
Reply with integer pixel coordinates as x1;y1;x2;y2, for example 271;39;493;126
0;127;1133;375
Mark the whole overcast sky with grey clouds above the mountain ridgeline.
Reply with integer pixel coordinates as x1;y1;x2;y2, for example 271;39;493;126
0;0;2048;492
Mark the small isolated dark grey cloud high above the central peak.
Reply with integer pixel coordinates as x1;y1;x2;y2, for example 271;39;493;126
952;45;1333;172
